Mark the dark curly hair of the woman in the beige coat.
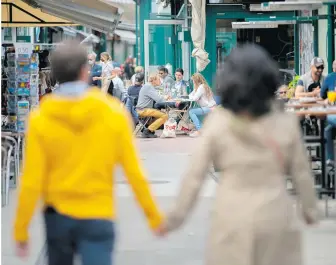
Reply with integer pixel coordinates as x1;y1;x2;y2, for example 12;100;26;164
217;44;280;117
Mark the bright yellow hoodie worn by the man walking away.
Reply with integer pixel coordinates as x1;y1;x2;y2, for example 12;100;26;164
14;89;162;242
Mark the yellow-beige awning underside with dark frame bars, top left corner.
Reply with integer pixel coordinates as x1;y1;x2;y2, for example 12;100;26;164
1;0;73;27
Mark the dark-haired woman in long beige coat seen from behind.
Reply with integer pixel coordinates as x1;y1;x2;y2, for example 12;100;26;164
158;46;316;265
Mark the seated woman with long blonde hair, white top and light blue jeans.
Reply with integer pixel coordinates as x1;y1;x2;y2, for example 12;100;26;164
189;73;216;137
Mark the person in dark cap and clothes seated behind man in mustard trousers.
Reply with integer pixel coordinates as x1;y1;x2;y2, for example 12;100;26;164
126;73;145;126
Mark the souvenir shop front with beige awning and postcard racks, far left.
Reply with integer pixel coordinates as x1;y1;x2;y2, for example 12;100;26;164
1;0;132;132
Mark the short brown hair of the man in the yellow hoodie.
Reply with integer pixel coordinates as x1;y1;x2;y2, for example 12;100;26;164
50;41;87;84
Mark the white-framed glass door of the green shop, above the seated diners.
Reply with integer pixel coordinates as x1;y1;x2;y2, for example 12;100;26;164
144;20;190;80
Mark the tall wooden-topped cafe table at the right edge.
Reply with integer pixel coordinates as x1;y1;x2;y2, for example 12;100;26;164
294;108;336;190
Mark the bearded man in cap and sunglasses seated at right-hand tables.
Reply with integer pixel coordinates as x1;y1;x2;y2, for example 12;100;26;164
295;57;324;98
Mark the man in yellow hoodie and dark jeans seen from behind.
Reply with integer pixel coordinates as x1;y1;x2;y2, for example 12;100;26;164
14;43;162;265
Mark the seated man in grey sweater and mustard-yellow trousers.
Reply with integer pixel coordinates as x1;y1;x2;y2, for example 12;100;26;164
136;75;168;138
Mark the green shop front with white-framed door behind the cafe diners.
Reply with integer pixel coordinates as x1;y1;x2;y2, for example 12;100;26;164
137;0;336;86
